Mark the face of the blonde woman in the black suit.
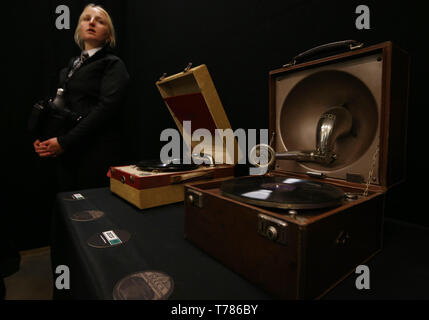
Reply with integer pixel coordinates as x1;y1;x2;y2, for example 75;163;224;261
79;8;109;50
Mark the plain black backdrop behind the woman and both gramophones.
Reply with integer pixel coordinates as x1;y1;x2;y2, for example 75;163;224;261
0;0;429;250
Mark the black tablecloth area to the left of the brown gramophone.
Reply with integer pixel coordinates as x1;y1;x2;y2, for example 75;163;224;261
51;188;270;300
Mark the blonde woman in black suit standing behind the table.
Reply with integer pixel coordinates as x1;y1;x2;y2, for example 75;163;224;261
33;4;129;191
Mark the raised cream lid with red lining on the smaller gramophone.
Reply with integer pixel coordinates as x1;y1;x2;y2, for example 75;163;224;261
156;64;240;163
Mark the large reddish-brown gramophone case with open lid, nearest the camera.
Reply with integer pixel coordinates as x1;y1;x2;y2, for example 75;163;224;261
185;42;409;299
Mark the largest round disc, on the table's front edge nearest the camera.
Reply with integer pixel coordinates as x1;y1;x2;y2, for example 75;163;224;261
113;271;174;300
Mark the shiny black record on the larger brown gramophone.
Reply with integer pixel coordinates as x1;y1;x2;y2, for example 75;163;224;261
220;176;344;209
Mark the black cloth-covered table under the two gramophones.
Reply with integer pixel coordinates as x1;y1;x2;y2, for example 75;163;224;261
51;188;429;300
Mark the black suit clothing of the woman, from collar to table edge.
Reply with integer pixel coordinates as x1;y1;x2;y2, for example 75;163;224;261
58;47;129;189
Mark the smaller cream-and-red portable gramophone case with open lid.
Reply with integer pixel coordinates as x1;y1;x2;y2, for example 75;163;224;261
109;65;238;209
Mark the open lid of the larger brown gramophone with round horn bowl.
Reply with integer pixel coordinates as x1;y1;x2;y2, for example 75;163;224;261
269;42;409;187
